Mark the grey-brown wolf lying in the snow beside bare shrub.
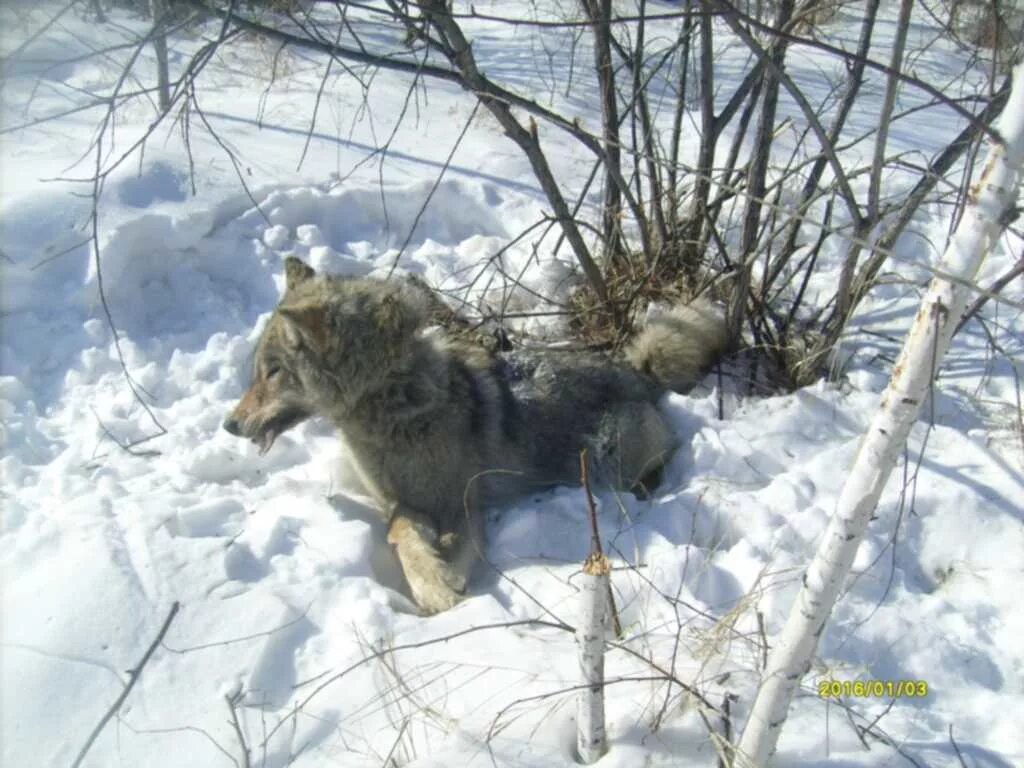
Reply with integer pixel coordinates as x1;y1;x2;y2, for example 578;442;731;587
223;257;726;613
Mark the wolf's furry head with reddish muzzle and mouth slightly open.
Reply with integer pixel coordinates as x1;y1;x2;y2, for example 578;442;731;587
224;257;425;454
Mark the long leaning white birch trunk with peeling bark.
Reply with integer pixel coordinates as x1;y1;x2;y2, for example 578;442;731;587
735;65;1024;768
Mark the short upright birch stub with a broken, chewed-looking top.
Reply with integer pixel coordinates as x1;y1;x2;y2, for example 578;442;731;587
575;552;610;765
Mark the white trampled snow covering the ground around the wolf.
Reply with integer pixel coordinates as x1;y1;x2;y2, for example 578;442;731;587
0;3;1024;768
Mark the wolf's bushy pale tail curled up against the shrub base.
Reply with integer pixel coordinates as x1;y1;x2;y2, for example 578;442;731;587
626;299;728;392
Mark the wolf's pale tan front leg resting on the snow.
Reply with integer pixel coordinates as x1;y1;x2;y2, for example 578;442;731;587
387;510;466;613
